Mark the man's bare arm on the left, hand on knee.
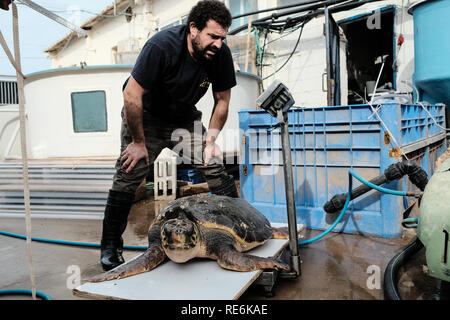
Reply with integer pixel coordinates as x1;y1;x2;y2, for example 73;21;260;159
121;76;150;173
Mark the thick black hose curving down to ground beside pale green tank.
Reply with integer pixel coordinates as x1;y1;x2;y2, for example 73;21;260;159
383;238;423;300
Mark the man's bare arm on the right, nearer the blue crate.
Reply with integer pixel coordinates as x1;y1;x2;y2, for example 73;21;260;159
205;89;231;165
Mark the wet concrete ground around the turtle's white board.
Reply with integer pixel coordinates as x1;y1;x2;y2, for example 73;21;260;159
0;196;448;300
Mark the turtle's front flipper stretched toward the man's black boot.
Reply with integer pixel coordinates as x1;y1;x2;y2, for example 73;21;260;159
83;245;166;282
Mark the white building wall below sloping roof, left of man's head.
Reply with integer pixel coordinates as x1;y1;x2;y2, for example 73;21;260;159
49;0;196;68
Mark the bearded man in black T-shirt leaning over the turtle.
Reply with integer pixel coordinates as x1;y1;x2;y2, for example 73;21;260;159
100;0;238;271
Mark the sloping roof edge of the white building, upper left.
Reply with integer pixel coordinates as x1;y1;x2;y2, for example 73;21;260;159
44;0;135;54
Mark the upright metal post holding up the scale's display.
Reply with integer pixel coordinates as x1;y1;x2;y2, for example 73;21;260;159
277;109;300;276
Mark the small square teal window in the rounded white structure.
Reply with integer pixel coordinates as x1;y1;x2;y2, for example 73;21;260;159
71;91;108;132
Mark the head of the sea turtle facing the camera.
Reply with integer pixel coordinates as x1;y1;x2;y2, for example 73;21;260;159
161;218;200;263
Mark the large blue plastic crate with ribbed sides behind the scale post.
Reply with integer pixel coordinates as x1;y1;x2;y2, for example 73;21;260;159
239;102;446;237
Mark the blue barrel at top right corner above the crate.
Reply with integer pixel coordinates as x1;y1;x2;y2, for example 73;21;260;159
409;0;450;127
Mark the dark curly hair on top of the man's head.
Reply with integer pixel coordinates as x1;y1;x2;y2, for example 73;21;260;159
187;0;232;31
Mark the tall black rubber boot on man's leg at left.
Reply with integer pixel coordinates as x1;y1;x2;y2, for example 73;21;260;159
100;189;134;271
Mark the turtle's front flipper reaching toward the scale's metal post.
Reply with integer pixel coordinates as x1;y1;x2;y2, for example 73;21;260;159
217;248;289;271
